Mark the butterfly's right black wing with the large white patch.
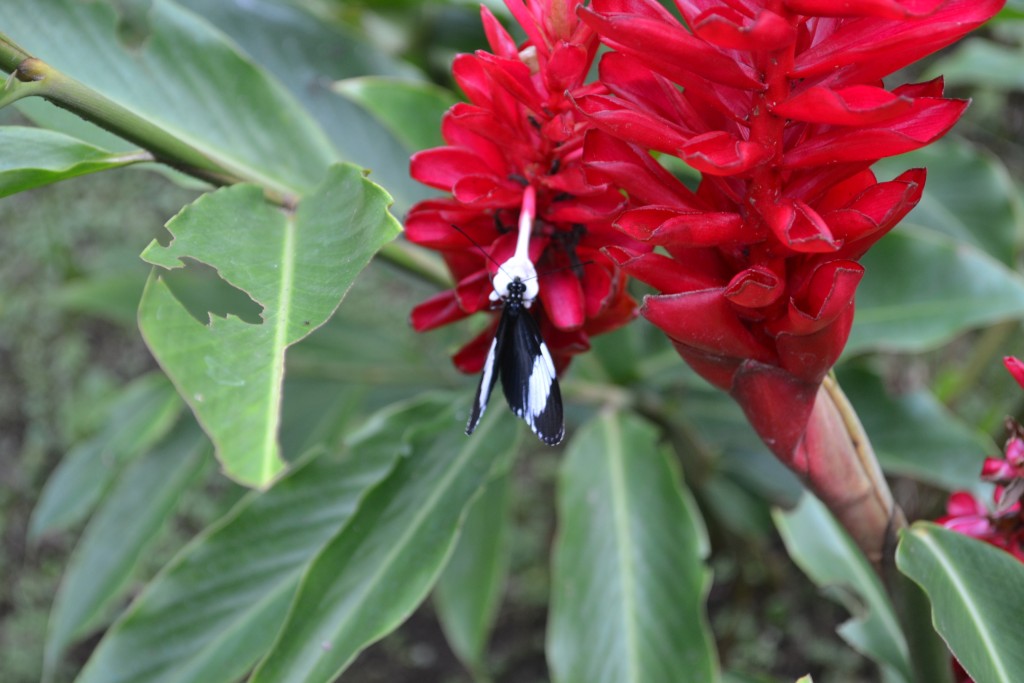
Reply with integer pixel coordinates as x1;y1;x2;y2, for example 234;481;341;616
497;307;565;445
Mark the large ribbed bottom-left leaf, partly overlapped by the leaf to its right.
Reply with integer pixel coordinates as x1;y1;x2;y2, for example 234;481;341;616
78;396;451;683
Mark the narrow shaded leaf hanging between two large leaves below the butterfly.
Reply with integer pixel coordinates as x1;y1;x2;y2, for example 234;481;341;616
434;476;509;678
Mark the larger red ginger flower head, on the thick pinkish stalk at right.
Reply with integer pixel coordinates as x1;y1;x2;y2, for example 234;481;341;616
575;0;1002;464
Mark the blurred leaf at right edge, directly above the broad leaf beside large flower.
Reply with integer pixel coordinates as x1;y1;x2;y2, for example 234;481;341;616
876;138;1024;267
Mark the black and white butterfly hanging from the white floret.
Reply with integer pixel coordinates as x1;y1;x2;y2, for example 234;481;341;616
466;276;565;445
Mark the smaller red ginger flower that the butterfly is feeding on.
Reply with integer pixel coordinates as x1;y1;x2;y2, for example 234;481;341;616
406;0;645;372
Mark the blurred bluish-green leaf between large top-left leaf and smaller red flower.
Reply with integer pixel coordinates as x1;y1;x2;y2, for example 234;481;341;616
174;0;430;213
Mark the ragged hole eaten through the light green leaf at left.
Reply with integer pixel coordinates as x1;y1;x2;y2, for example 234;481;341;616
161;258;263;325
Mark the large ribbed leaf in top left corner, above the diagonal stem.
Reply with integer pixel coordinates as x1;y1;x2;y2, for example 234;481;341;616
0;0;339;194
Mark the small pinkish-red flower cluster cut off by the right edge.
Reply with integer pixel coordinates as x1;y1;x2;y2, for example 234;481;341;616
937;357;1024;562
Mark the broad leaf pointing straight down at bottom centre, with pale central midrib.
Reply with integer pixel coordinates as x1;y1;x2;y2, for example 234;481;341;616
547;413;719;683
